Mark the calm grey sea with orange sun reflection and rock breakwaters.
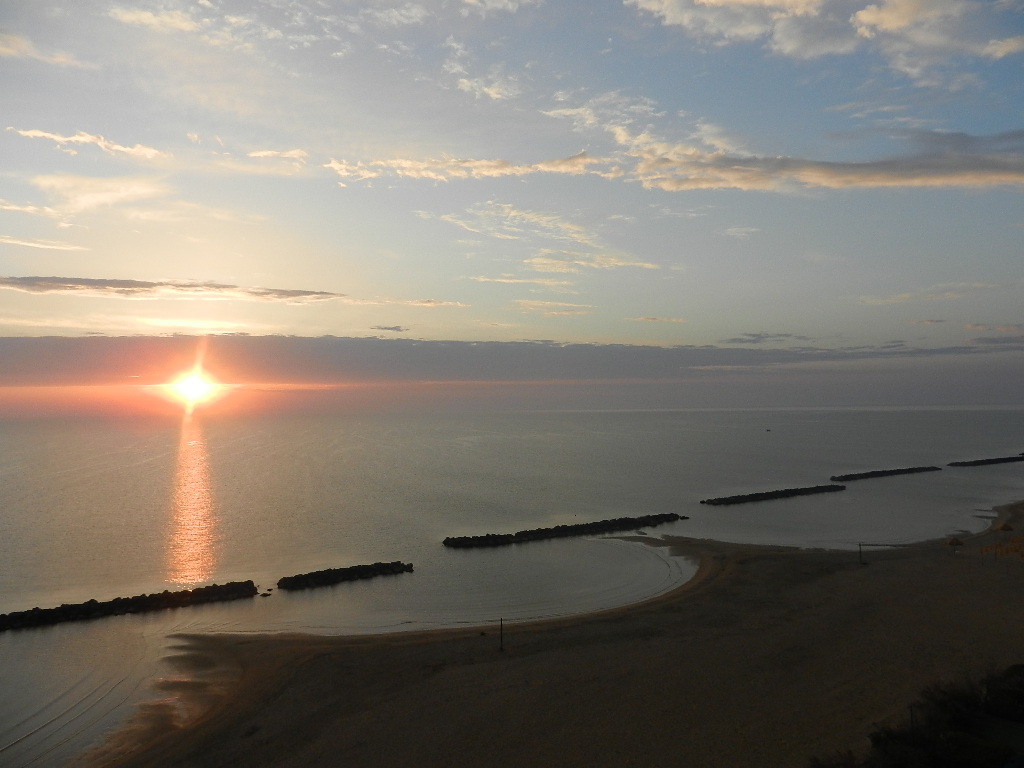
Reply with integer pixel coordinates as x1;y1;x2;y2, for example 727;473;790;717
0;408;1024;768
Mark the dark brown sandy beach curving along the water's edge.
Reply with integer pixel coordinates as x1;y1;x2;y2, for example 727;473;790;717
79;502;1024;768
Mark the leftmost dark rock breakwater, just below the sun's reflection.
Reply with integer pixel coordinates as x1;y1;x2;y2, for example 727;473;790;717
0;581;257;632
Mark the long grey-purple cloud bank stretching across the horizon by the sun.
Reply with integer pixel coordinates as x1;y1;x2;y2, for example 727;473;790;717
0;334;1024;393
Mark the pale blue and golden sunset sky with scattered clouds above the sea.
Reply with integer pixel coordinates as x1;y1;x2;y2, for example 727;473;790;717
0;0;1024;404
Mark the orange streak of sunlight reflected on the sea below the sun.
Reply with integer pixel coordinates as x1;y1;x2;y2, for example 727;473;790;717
167;417;216;589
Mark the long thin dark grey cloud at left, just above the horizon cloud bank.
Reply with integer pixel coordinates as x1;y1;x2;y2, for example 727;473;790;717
0;276;344;304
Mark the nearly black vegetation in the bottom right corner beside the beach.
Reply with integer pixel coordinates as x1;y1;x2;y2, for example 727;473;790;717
810;665;1024;768
